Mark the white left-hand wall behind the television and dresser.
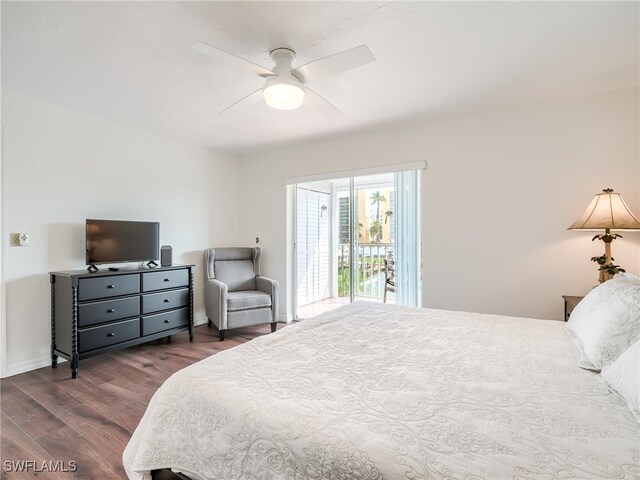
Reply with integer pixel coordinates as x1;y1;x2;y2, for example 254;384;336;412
2;90;239;376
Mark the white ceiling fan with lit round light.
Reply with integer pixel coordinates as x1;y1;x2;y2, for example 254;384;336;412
189;43;375;118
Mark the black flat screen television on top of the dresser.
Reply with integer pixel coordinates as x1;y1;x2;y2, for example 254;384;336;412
86;218;160;265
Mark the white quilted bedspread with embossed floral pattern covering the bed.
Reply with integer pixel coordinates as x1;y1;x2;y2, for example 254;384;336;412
124;303;640;480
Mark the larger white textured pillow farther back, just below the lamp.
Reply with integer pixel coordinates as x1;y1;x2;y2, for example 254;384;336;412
567;275;640;370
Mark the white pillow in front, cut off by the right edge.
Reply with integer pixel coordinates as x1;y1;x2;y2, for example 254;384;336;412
600;341;640;419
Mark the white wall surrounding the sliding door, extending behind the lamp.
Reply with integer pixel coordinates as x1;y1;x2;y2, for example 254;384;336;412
240;88;640;319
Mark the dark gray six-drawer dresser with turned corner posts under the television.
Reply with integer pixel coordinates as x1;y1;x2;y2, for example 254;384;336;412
49;265;194;378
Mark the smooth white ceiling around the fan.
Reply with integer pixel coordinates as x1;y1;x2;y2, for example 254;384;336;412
1;1;640;154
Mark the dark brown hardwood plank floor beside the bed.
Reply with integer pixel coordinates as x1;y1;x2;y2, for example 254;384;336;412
0;324;272;480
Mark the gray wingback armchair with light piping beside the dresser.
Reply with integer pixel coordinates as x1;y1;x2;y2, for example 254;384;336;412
204;247;278;341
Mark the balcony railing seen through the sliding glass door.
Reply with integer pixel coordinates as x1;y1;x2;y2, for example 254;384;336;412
338;243;393;298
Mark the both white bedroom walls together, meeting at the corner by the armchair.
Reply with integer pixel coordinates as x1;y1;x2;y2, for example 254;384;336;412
0;89;640;376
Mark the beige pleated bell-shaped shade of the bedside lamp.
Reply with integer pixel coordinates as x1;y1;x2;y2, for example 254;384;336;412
567;188;640;230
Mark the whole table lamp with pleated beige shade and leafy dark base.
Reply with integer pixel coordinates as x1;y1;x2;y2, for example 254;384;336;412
567;188;640;283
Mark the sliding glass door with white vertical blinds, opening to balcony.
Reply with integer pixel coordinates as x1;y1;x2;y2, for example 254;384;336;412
294;171;421;319
